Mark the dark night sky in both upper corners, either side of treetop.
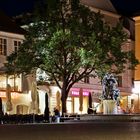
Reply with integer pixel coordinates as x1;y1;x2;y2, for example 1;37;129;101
0;0;140;16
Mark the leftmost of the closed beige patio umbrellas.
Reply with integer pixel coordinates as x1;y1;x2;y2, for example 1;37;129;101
6;84;13;111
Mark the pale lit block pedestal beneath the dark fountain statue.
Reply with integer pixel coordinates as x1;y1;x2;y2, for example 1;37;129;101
103;100;118;114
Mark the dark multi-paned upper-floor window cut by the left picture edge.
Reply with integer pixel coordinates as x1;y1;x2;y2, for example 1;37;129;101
0;38;7;56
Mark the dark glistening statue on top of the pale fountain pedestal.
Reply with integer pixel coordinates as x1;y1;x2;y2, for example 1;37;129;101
102;73;120;104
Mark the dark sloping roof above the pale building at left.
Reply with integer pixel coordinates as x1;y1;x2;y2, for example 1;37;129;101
0;11;25;34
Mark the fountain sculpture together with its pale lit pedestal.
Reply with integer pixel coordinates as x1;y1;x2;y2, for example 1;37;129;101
102;73;120;114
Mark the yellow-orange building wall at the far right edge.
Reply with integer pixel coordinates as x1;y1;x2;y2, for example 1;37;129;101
134;17;140;81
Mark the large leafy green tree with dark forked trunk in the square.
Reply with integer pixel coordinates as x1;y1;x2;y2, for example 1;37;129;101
7;0;138;113
